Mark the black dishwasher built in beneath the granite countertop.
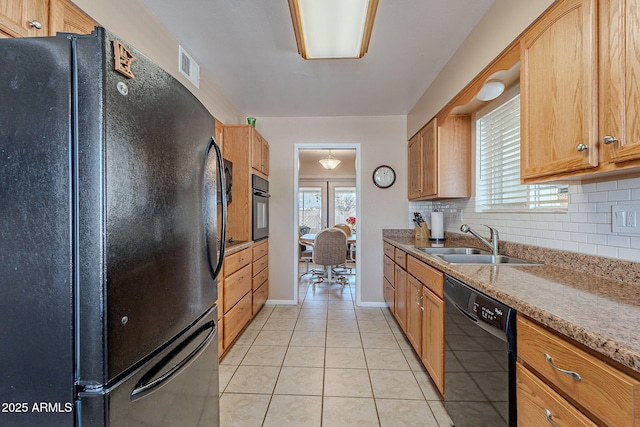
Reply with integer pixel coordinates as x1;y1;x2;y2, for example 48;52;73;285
444;275;516;427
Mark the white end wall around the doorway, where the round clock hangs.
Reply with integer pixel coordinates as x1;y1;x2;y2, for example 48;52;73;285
256;116;408;303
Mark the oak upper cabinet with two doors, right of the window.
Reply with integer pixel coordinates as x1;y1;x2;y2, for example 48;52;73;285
520;0;640;183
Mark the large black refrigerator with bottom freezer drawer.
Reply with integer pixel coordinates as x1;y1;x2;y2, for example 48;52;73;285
0;28;226;427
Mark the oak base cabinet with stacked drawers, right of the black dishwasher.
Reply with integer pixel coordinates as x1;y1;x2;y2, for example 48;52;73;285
516;315;640;426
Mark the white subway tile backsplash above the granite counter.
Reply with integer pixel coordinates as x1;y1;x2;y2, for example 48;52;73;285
407;178;640;262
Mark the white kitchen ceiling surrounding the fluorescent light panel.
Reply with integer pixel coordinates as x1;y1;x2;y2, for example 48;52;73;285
144;0;493;117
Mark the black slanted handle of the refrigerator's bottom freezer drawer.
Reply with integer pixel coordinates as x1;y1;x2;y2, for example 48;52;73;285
131;320;218;402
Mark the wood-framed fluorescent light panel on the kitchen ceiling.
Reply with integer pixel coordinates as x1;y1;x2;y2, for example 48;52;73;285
289;0;378;59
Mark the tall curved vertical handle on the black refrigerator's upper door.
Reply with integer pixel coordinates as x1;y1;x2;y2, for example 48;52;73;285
202;136;227;280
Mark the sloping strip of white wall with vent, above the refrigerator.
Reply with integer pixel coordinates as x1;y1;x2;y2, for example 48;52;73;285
73;0;244;124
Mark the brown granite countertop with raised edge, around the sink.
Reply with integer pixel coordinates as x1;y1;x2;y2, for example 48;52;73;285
383;230;640;377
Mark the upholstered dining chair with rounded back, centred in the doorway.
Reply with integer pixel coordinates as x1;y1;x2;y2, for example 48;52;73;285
313;228;347;287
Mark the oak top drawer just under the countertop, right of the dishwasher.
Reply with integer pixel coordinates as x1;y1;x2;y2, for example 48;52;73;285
516;316;640;426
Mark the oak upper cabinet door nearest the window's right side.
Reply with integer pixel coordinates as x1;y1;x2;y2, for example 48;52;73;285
520;0;598;180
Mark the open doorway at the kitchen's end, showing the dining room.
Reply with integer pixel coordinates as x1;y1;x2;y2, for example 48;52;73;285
294;144;362;305
